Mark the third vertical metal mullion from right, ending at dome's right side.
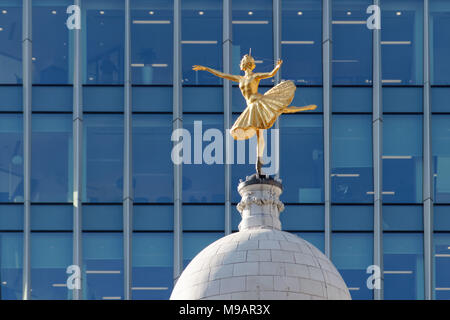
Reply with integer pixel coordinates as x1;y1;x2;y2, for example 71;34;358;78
322;0;332;258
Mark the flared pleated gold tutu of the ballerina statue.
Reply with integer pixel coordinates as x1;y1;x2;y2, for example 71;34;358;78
230;81;300;140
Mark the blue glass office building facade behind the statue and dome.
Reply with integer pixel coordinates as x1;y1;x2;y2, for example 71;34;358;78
0;0;450;299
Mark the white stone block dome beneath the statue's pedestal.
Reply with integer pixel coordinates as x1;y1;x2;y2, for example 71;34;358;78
170;229;351;300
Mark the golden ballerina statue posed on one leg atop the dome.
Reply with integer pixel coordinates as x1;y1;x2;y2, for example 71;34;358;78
192;54;317;176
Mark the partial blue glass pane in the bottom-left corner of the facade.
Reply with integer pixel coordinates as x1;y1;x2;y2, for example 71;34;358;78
0;232;23;300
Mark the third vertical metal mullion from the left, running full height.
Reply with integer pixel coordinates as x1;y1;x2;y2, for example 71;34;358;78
123;0;133;300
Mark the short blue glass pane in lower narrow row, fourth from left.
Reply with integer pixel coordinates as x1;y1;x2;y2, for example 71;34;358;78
133;205;173;231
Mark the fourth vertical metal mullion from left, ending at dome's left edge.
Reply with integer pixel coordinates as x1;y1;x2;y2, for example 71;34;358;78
172;0;183;282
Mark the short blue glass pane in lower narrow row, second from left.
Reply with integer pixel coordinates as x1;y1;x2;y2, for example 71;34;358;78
31;205;73;231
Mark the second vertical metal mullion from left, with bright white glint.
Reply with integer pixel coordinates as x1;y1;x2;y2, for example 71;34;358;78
72;0;84;300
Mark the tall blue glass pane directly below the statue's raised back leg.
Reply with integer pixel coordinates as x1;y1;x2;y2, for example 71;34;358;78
280;114;324;203
